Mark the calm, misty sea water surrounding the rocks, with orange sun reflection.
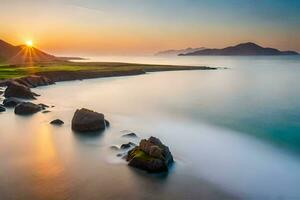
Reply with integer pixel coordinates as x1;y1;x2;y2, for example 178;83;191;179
0;56;300;200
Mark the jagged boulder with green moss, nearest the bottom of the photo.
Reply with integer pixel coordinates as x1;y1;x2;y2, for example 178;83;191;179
126;137;174;173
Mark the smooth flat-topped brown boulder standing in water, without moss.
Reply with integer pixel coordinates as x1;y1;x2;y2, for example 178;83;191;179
72;108;106;132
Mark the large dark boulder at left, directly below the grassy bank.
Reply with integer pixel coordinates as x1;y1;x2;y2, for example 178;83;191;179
4;81;38;99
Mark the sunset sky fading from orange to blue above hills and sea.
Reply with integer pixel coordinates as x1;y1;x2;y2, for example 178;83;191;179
0;0;300;55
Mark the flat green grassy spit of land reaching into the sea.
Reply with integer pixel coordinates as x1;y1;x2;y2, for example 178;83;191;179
0;62;217;82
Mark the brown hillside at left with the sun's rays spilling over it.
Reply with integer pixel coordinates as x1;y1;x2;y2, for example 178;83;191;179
0;40;59;64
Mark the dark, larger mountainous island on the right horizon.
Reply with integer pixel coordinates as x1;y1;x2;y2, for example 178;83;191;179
179;42;298;56
